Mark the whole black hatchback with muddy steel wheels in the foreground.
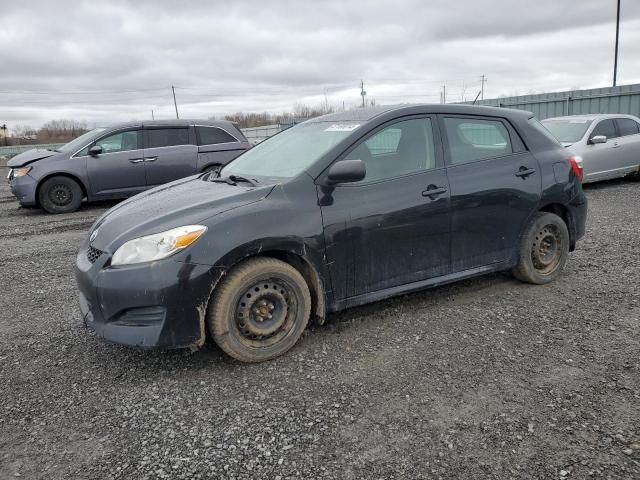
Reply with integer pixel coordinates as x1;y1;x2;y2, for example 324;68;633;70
76;105;587;362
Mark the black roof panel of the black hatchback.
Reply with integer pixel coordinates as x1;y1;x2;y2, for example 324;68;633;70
307;103;533;123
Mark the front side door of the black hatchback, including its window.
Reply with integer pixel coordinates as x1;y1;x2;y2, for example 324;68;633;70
318;116;451;300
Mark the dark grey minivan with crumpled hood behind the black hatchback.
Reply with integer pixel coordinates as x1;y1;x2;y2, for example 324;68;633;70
7;120;251;213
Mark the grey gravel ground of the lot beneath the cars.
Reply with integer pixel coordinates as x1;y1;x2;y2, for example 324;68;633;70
0;181;640;480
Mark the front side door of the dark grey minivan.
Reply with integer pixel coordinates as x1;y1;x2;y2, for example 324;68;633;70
87;128;147;198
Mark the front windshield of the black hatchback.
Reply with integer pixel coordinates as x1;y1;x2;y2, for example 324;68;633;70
220;122;360;178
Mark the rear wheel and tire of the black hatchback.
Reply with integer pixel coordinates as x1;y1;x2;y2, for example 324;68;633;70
513;212;569;285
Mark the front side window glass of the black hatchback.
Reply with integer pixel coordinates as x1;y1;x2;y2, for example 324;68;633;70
345;118;436;182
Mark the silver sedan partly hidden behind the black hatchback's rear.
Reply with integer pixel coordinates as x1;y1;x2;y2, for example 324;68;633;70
542;114;640;183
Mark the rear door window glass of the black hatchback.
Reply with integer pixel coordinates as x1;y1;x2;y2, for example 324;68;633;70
444;118;513;165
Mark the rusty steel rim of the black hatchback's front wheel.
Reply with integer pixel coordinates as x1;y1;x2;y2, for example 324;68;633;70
234;278;298;347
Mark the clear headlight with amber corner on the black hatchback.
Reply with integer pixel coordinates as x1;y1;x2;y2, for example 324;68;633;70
111;225;207;265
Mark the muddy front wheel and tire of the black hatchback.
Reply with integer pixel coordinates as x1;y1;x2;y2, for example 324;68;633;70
207;258;311;363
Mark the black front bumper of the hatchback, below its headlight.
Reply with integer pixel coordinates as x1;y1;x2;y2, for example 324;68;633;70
76;248;223;348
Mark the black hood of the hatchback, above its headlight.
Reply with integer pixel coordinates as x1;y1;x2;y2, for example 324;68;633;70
90;176;273;253
